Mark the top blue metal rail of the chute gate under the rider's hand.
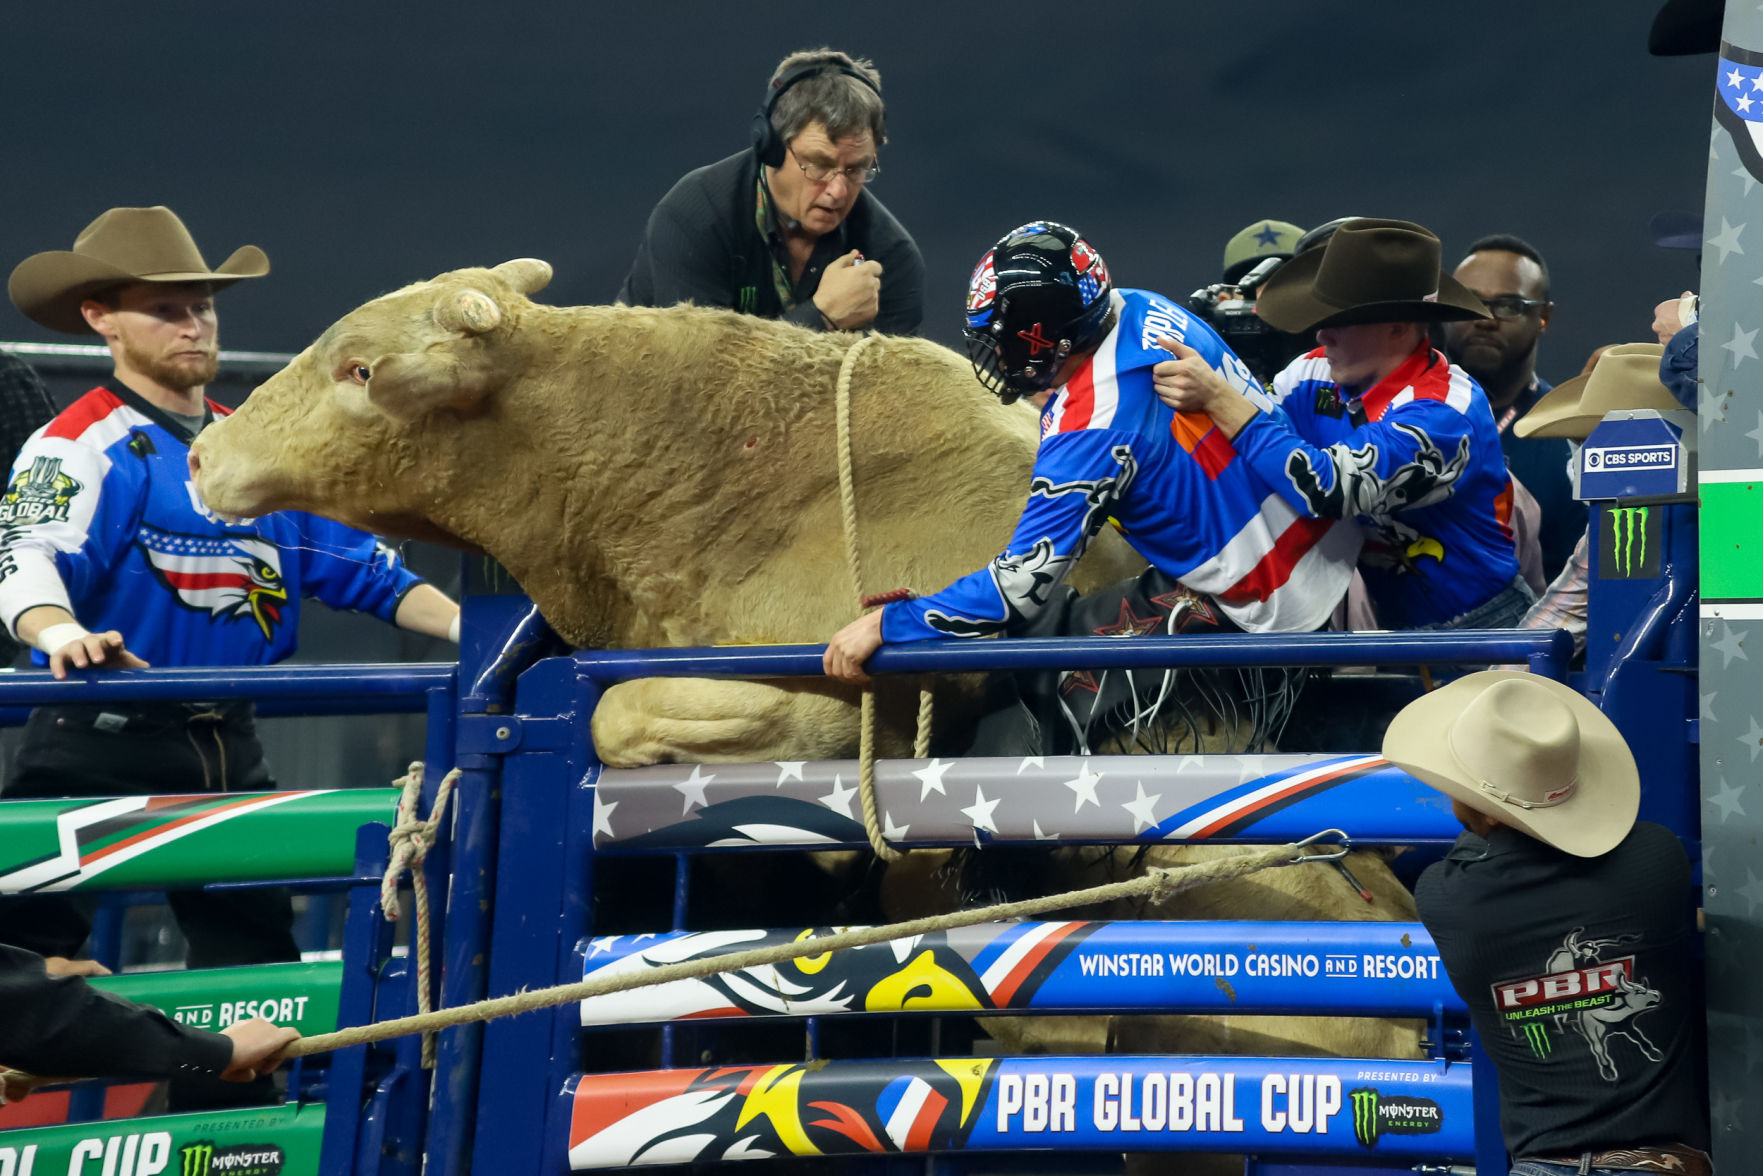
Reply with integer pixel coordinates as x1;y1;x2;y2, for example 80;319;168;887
575;629;1573;684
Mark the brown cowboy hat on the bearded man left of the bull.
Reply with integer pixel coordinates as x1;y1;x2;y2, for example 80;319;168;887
7;205;270;335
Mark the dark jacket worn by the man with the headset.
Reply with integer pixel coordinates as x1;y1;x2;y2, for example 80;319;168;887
619;152;924;335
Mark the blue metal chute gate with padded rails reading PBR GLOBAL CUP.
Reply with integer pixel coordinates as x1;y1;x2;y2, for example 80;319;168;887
454;620;1571;1172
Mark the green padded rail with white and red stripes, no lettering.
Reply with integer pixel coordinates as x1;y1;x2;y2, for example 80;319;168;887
0;788;398;892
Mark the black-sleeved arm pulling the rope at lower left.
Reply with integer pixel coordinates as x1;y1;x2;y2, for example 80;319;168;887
0;945;300;1081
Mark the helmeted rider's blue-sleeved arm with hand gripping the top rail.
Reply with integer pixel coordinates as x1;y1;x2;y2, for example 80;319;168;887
823;430;1139;682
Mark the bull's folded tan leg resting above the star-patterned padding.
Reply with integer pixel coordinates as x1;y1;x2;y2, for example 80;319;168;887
594;677;857;767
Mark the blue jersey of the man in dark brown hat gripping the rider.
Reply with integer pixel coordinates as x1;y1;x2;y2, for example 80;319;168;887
1236;347;1518;628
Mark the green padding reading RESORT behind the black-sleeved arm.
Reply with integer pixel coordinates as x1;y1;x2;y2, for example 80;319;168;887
93;959;342;1036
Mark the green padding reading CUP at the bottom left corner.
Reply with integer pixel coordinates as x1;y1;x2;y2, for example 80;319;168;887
0;1104;324;1176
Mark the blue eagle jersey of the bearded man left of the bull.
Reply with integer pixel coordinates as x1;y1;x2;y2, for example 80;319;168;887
0;388;421;666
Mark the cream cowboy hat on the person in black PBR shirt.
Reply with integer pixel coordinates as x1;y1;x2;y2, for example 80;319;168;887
1384;670;1641;857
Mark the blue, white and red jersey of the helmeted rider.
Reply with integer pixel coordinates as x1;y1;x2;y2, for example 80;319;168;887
882;289;1359;642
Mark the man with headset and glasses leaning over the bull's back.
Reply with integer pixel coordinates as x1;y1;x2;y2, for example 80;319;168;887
619;49;924;335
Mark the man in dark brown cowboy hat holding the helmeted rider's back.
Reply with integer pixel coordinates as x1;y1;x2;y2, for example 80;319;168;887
1153;217;1534;628
